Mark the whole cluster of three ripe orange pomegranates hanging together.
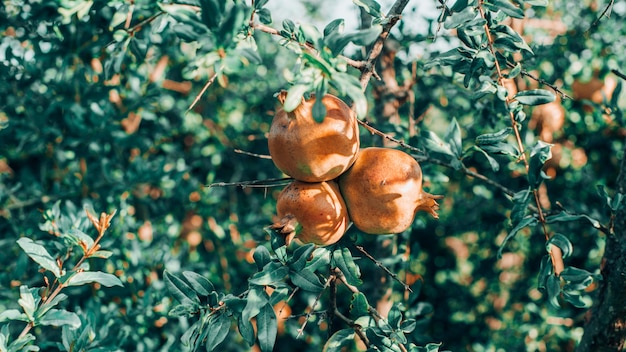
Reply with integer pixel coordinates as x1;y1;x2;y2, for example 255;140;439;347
268;91;442;245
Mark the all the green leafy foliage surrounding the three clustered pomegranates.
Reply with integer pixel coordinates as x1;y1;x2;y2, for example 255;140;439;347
0;0;626;351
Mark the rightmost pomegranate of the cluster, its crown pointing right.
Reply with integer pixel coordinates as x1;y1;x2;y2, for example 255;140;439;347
339;147;443;234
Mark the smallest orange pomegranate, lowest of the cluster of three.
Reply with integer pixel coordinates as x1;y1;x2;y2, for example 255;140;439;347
272;181;350;245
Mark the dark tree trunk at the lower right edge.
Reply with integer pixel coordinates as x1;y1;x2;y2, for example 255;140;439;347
576;148;626;352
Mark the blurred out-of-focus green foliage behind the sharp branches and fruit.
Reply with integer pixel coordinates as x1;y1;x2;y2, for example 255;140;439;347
0;0;626;351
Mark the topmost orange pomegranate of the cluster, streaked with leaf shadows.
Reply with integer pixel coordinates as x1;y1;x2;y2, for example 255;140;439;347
268;91;359;182
